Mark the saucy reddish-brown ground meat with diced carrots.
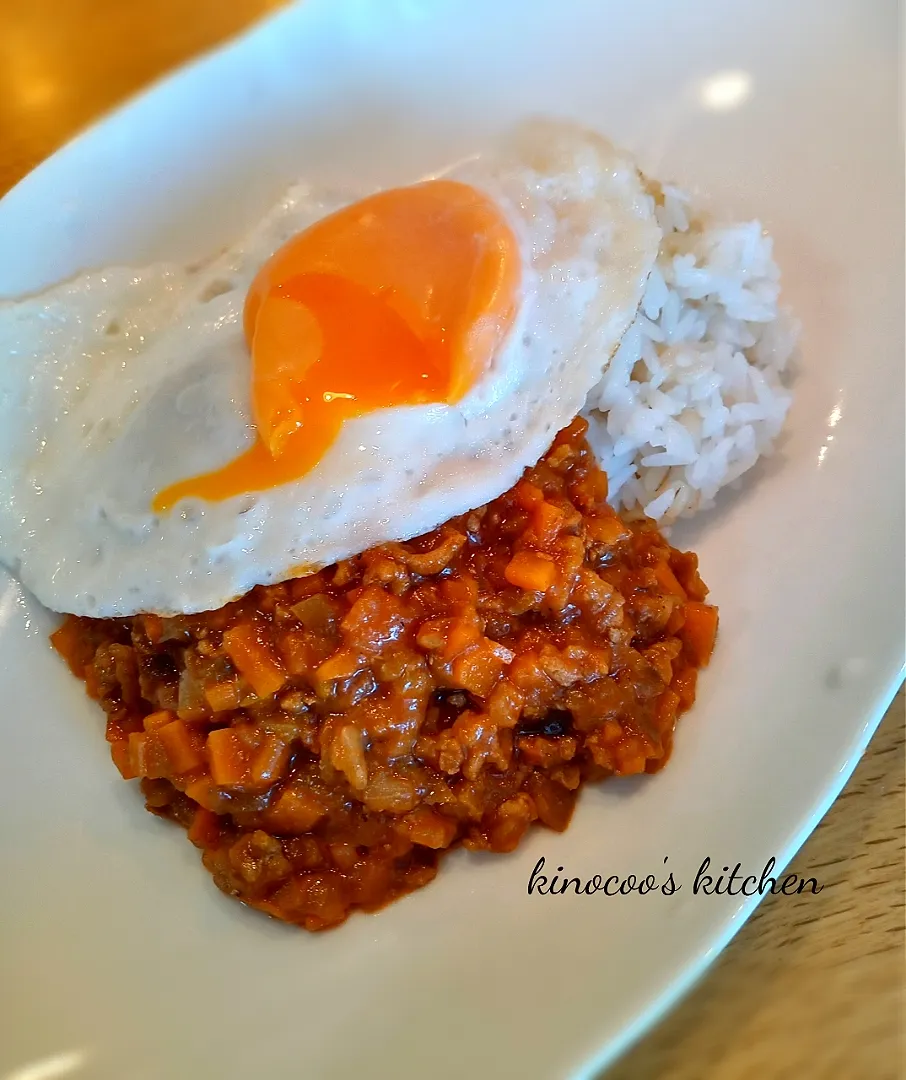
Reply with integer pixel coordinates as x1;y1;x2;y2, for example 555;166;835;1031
53;420;717;930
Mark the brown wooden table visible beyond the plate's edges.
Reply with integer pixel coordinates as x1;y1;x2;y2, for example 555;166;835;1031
0;0;906;1080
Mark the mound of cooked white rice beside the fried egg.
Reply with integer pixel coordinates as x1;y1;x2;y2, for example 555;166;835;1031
584;185;798;525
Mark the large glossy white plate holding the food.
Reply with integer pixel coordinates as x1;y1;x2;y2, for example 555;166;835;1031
0;0;904;1080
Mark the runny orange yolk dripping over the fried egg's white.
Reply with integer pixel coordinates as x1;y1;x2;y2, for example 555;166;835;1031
153;180;522;511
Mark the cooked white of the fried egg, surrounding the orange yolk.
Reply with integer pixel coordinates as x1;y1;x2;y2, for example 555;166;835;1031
0;121;661;617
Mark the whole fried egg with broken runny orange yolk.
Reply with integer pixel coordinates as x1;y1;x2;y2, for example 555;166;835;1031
0;121;661;617
